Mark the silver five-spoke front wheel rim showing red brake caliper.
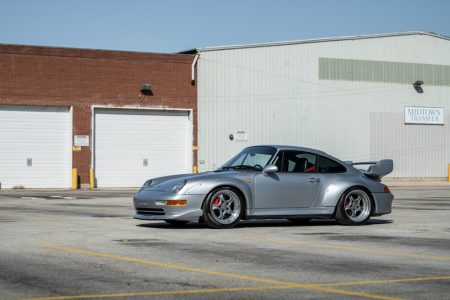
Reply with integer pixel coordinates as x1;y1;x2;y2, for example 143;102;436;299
209;190;241;225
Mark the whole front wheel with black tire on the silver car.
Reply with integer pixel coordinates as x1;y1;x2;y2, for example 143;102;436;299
203;187;244;229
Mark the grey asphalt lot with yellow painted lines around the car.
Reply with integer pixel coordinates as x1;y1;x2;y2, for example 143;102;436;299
0;186;450;300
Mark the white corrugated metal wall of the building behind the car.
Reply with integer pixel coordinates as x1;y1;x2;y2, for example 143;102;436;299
198;34;450;177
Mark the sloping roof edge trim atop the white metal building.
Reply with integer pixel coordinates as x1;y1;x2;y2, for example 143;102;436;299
192;31;450;54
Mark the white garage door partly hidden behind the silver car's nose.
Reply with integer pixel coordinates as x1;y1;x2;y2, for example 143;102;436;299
94;109;192;187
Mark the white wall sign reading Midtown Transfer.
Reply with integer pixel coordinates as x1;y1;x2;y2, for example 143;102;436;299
405;106;444;125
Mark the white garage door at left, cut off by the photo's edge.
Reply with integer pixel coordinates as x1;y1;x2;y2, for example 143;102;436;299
0;106;72;188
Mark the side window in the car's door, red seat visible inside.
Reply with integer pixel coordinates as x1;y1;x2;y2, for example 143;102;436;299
281;151;317;173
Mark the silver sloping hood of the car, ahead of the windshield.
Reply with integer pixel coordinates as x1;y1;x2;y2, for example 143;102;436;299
144;170;249;191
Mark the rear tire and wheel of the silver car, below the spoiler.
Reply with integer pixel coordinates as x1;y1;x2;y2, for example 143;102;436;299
336;187;373;225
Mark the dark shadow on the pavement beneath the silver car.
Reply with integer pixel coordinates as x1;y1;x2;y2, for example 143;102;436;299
136;219;394;230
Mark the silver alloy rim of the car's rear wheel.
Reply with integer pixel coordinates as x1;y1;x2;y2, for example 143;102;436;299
344;189;372;223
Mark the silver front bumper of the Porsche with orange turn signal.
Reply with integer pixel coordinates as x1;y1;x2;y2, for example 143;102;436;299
133;190;206;221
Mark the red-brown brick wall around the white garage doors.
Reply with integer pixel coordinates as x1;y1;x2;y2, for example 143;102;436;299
0;44;197;185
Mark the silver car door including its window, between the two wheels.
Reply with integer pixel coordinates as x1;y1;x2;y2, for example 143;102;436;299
255;150;320;209
